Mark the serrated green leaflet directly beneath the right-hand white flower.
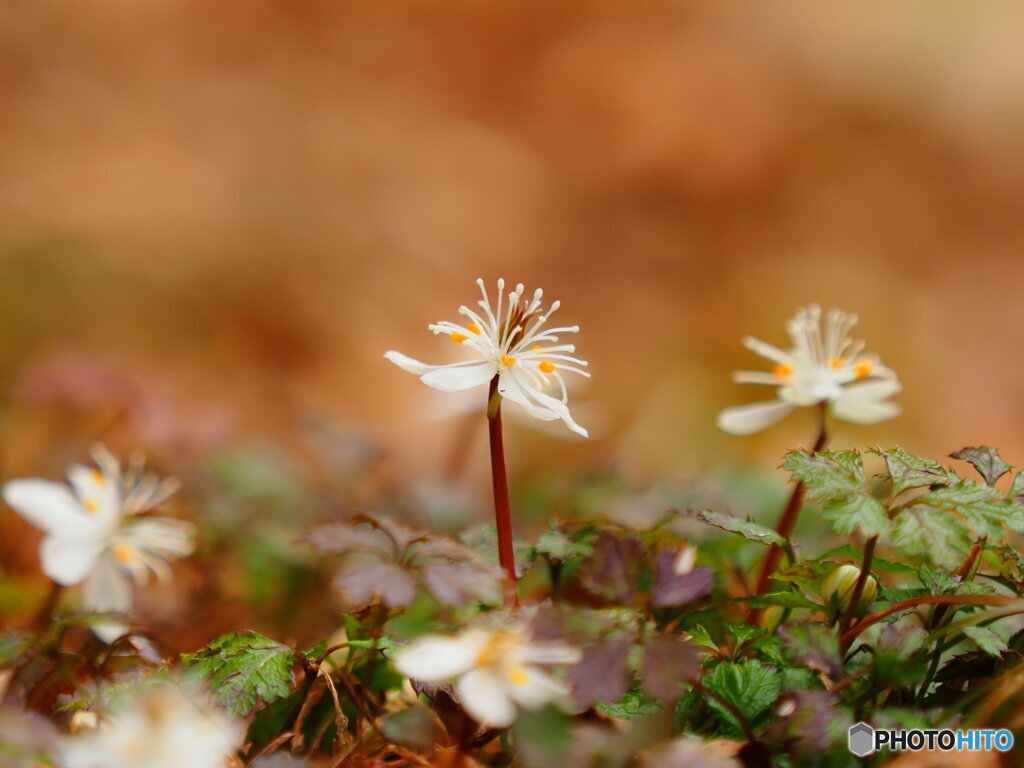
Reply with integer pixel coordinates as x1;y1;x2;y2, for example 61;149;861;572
782;451;889;537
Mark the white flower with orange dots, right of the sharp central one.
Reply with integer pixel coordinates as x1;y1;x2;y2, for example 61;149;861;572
718;305;900;434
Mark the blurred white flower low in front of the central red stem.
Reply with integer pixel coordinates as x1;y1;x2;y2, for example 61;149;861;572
395;628;580;728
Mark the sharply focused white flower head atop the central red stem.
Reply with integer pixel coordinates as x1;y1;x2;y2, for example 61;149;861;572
384;280;590;437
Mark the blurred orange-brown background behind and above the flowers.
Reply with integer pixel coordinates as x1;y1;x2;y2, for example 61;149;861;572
0;0;1024;489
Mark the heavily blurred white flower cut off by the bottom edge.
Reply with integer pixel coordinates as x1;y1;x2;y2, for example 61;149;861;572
57;685;243;768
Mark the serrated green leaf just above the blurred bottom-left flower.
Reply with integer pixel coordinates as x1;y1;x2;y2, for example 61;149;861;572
181;632;296;715
